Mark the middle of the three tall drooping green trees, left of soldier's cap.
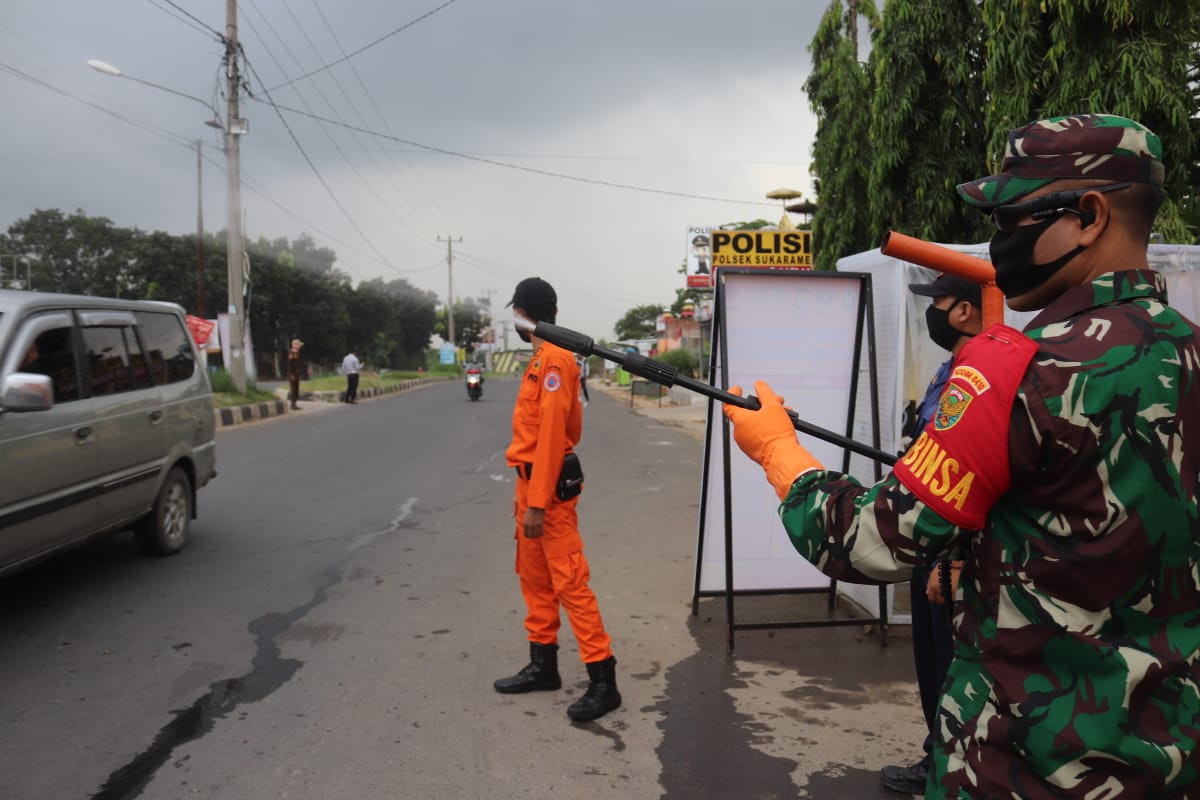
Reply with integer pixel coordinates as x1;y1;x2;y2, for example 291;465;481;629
868;0;991;245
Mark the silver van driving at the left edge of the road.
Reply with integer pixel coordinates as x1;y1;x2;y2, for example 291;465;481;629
0;290;216;575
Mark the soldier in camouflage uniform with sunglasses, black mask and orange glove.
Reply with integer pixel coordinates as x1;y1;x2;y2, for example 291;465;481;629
725;115;1200;799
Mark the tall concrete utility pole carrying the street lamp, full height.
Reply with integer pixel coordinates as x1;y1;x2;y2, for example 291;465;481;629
224;0;246;395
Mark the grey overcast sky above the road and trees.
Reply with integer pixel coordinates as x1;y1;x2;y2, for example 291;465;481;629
0;0;828;338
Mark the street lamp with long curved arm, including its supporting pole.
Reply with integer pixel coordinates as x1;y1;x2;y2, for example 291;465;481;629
88;56;248;393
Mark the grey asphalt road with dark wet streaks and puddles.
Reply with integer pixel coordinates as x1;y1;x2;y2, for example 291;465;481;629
0;379;920;800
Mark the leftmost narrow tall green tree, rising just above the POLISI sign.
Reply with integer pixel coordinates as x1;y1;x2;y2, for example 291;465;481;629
804;0;878;270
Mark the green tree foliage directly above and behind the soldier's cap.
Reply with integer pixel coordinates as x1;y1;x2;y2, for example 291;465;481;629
983;0;1200;242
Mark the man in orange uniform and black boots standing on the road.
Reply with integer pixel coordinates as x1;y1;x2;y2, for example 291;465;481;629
493;278;620;721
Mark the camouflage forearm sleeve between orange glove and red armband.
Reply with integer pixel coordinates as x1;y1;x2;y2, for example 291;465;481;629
779;471;961;583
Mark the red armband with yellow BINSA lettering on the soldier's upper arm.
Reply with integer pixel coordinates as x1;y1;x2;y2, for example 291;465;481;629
894;324;1038;530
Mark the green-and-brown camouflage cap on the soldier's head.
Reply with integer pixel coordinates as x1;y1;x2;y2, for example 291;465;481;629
959;114;1164;210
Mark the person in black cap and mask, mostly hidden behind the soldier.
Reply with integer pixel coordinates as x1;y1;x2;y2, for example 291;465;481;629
880;275;983;794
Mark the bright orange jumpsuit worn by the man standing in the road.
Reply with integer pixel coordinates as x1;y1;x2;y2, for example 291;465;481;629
504;342;612;663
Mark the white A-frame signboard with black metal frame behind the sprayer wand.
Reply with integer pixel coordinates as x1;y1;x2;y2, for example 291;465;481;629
692;267;888;651
